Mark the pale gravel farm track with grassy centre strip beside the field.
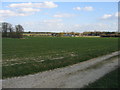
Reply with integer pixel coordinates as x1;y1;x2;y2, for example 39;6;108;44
2;52;120;88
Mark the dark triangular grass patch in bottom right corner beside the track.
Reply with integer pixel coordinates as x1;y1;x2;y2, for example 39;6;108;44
85;69;120;88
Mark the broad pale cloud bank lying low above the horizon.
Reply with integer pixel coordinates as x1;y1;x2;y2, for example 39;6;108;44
22;19;118;32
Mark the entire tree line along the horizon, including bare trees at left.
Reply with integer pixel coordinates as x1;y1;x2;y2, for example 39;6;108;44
0;22;120;38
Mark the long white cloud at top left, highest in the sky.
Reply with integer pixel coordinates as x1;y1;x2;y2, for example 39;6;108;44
9;1;58;8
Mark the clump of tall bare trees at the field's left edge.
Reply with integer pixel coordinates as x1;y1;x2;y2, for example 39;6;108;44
1;22;24;38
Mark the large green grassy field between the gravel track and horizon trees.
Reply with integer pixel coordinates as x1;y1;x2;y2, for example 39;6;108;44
2;37;118;78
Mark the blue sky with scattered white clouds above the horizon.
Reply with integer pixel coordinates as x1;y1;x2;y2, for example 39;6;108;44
0;0;119;32
